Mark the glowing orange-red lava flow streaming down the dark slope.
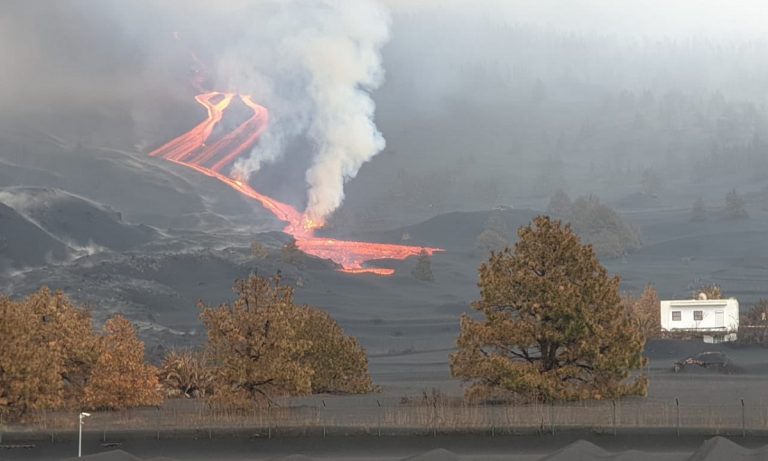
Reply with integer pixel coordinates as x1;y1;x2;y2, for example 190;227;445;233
149;91;442;275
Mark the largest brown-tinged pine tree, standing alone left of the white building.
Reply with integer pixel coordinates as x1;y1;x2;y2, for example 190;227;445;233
451;216;647;401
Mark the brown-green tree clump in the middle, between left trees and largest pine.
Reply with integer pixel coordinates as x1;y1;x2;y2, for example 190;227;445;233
201;276;373;408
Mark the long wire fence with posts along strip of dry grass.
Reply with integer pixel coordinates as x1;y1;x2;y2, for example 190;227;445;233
6;399;768;440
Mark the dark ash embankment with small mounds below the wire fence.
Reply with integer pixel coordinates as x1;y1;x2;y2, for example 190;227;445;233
0;430;768;461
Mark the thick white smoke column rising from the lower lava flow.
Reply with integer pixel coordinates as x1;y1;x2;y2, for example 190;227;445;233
302;0;389;221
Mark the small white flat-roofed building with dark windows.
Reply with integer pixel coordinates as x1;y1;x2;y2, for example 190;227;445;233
661;298;739;342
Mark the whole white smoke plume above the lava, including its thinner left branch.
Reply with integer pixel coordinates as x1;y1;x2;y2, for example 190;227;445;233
224;0;390;222
